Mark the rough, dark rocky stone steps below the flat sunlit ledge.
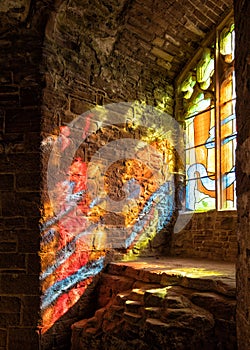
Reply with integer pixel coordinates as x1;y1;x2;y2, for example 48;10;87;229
71;263;236;350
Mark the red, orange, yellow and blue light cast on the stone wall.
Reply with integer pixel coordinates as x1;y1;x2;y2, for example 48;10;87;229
41;104;178;332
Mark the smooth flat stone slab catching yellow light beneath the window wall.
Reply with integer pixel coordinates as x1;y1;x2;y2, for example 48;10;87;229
107;258;236;297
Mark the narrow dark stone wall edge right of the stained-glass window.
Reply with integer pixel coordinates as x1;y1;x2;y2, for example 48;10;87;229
235;1;250;350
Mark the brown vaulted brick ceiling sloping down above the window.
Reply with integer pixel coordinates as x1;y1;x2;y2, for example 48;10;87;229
0;0;232;79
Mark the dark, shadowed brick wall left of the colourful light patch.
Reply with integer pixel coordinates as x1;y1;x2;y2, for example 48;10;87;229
0;1;42;350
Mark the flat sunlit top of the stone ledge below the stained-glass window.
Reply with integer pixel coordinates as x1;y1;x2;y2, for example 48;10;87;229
107;257;236;296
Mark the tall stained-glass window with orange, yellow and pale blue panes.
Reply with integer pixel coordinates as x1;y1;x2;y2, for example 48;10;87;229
180;24;236;211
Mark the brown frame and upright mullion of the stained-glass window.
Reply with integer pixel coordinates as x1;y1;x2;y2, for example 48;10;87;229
175;11;237;212
